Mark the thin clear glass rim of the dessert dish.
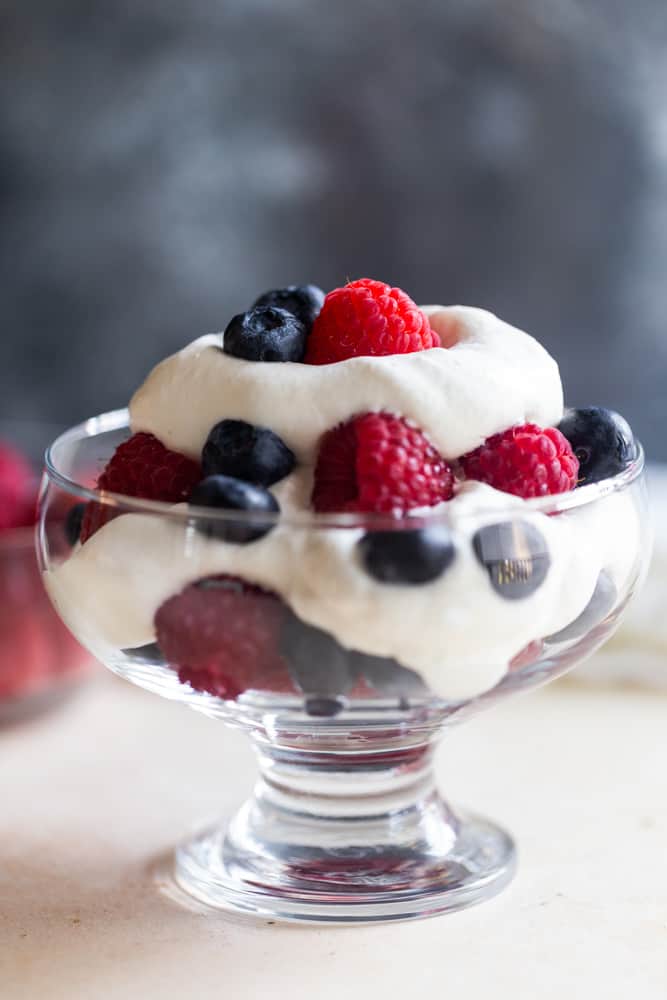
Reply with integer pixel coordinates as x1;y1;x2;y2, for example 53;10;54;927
41;408;645;530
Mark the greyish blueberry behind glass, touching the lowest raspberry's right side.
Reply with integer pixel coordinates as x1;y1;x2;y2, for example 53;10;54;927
280;612;357;699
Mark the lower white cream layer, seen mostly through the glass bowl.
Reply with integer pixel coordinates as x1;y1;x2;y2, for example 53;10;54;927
46;484;638;698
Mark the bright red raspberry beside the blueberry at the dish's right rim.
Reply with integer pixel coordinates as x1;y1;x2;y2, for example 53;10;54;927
461;424;579;499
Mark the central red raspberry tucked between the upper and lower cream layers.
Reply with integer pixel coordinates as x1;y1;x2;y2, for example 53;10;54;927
312;413;454;514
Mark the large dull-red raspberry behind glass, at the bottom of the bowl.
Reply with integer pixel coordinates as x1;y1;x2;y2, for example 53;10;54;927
155;576;294;698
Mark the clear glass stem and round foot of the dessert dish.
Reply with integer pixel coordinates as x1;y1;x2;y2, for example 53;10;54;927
175;744;516;923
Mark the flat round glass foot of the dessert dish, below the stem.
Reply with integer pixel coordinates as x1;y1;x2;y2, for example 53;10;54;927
175;819;516;924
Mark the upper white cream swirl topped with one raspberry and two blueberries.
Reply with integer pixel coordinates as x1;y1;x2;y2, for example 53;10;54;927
130;306;563;464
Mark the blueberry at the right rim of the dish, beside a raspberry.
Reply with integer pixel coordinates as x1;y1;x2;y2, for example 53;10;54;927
558;406;637;486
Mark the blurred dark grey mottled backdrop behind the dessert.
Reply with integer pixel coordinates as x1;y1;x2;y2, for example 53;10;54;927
0;0;667;459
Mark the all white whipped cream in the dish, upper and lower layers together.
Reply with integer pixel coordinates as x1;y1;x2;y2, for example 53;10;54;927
46;306;639;699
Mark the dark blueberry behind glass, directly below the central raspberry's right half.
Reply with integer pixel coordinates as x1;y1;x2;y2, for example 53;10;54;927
359;525;456;584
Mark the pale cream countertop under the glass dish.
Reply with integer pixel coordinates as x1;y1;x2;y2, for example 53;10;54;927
0;674;667;1000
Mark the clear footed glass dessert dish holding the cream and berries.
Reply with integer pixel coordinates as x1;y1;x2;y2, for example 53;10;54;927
39;411;650;923
